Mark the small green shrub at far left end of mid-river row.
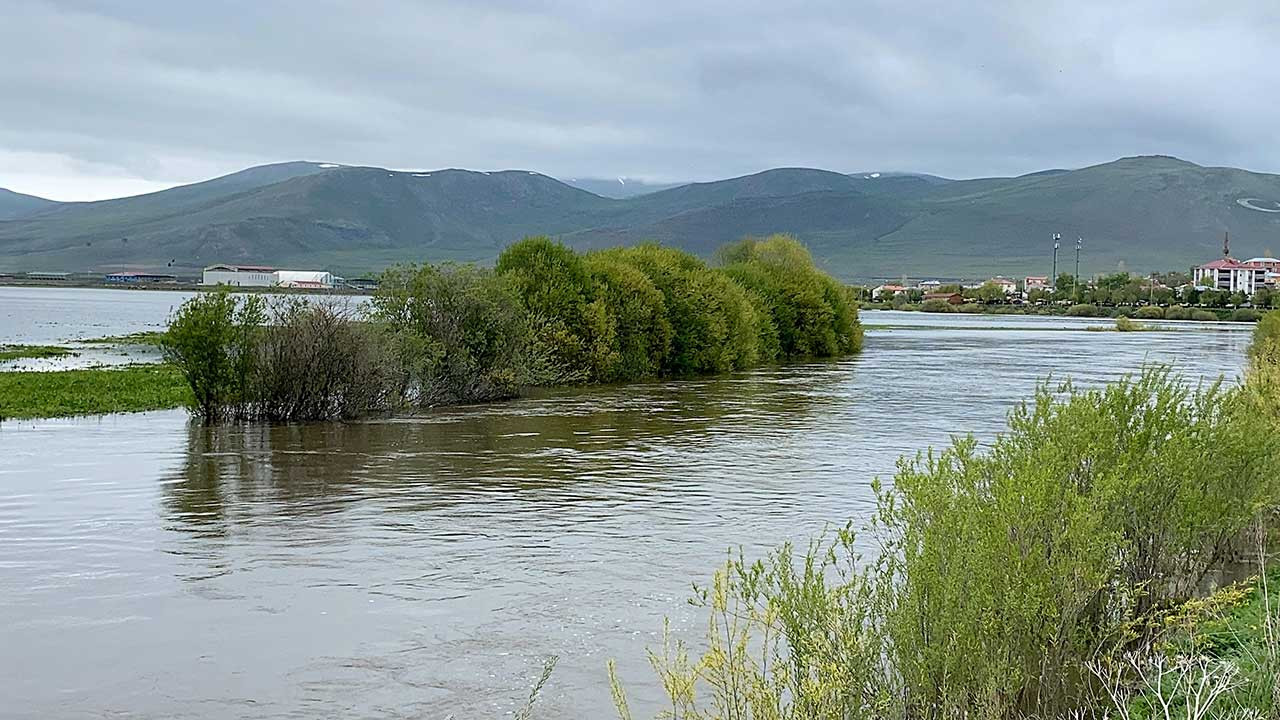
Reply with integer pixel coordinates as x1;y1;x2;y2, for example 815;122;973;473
160;291;265;421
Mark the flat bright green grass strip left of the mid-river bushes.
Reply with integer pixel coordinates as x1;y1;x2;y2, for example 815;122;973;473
0;365;191;419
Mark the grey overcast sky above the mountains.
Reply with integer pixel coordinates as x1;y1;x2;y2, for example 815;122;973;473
0;0;1280;200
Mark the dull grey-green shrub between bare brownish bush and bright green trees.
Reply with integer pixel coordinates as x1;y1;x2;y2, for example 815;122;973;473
371;264;530;407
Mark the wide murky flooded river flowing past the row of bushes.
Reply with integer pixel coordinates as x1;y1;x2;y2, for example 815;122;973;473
0;291;1249;720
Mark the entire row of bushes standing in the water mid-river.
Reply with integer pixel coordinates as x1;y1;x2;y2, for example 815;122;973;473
163;236;863;421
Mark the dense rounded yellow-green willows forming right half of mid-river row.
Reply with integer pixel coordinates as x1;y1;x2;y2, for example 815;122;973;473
495;236;863;384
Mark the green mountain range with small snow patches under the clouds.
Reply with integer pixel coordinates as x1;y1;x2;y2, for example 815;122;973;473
0;156;1280;281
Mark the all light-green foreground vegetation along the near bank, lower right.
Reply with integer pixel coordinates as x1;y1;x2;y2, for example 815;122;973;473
611;315;1280;720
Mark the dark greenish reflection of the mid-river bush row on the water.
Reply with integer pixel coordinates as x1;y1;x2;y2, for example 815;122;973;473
164;363;846;536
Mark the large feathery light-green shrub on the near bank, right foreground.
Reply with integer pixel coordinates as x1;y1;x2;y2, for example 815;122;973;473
881;370;1277;714
